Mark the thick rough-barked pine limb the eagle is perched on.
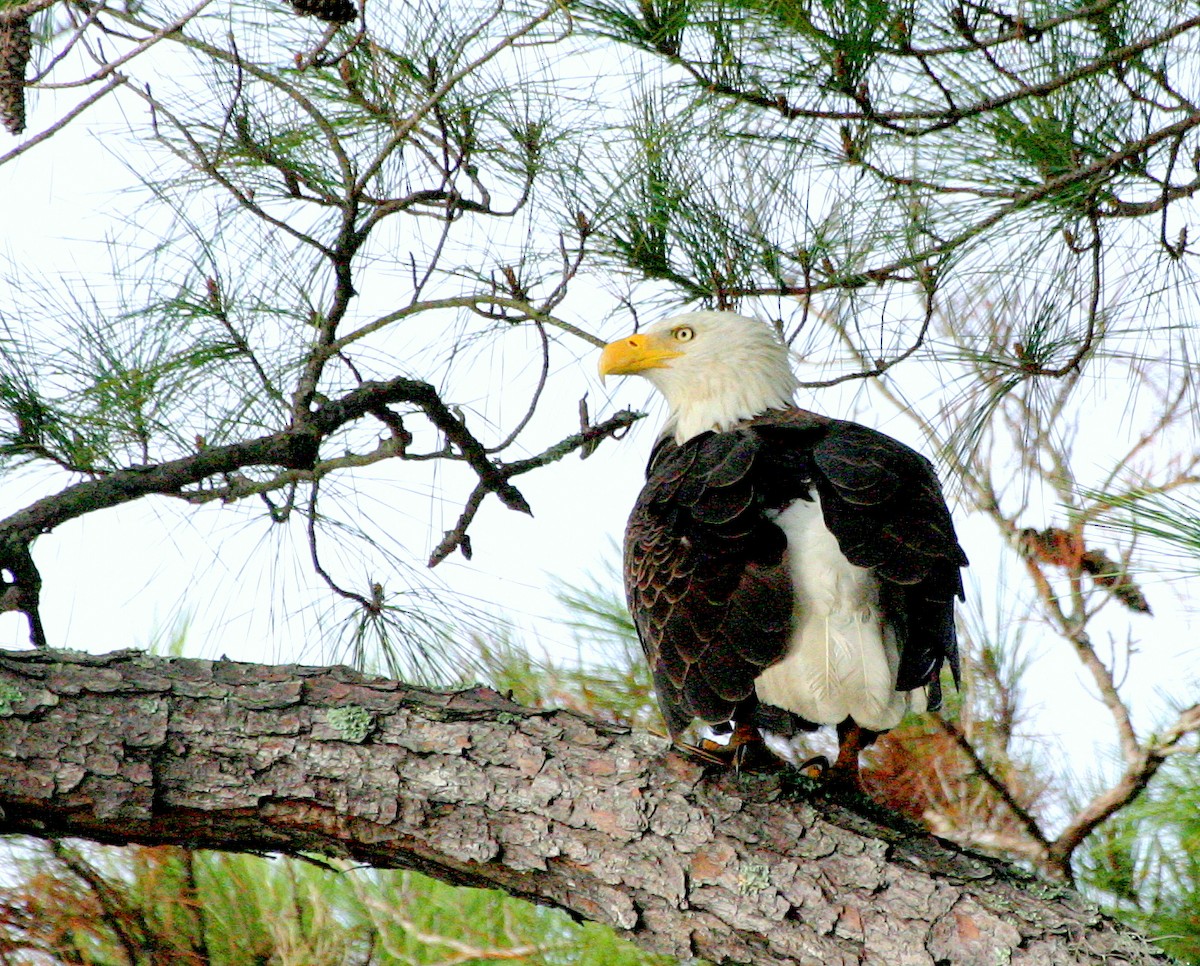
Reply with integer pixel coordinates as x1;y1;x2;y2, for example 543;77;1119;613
0;650;1169;966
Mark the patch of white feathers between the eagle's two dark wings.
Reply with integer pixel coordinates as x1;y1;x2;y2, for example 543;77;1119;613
755;494;925;731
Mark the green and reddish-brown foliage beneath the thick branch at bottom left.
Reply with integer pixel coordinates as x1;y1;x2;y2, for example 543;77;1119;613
0;845;666;966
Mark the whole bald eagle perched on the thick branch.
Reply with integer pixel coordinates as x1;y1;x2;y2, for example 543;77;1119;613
600;312;967;785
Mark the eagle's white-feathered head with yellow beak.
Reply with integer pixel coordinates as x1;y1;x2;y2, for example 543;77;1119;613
600;312;798;443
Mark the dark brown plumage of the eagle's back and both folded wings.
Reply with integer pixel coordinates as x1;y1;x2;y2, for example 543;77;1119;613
625;409;966;734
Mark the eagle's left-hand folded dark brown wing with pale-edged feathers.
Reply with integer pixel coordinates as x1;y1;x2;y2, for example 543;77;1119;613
625;427;804;734
